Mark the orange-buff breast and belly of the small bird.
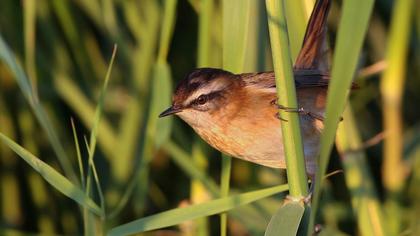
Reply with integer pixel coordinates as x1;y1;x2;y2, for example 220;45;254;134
193;104;285;168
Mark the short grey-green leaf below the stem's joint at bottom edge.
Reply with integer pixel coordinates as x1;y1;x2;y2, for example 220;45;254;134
264;202;305;236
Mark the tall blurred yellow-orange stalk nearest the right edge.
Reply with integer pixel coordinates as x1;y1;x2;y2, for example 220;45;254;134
380;0;414;235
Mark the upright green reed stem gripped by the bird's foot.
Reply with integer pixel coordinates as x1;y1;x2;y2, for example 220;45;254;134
266;0;308;198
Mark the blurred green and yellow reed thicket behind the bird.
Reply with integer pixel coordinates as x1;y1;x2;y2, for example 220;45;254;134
0;0;420;235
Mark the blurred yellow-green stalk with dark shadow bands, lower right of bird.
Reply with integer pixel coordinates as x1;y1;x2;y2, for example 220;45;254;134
336;106;388;235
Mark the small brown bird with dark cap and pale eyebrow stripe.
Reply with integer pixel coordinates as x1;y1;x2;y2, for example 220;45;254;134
159;0;330;176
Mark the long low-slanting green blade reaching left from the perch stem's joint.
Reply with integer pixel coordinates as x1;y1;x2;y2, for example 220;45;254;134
109;185;288;236
